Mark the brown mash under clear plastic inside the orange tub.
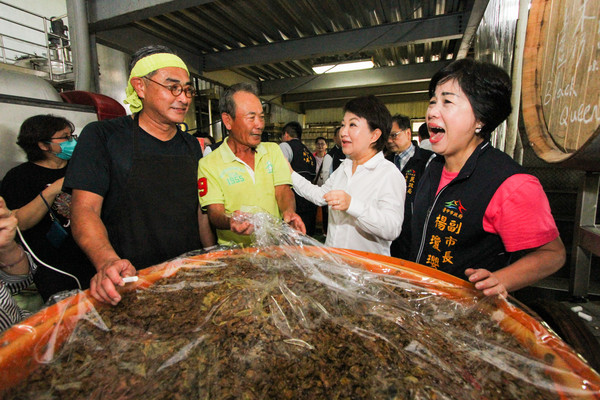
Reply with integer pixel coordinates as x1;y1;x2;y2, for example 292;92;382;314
6;251;558;400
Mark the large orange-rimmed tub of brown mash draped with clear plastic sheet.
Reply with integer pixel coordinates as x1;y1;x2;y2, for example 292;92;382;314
0;214;600;399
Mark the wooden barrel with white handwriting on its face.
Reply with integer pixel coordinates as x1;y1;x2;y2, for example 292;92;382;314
522;0;600;171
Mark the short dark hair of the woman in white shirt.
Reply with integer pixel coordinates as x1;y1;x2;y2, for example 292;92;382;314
344;95;392;151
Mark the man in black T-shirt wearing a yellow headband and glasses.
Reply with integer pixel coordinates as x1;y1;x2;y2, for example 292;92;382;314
64;46;215;304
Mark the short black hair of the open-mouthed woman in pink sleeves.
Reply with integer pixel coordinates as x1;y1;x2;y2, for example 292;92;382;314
429;58;512;140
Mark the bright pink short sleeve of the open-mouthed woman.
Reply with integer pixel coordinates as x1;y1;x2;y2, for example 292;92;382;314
483;174;559;252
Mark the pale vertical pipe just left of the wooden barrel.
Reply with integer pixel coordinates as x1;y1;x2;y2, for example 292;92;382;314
504;0;529;158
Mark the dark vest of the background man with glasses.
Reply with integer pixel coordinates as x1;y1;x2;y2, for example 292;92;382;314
390;146;433;260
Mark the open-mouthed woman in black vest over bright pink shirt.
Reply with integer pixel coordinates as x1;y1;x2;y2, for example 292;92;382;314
411;59;565;296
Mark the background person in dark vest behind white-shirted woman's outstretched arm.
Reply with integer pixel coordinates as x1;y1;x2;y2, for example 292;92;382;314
280;121;317;236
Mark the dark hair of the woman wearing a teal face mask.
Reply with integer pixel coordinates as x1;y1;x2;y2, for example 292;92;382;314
17;114;75;162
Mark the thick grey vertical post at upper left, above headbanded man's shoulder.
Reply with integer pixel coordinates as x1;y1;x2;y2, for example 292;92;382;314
67;0;93;91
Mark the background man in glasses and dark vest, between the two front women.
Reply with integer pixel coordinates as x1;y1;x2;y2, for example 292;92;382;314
387;114;435;259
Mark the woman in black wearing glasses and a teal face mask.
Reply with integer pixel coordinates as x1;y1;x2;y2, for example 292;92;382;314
0;115;95;301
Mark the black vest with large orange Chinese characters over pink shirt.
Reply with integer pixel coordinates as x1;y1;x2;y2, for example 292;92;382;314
410;141;525;279
